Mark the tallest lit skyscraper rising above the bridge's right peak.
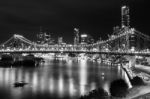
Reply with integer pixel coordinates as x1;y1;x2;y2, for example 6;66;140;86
121;5;130;28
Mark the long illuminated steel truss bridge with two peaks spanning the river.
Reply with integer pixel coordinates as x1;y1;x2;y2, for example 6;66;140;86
0;27;150;56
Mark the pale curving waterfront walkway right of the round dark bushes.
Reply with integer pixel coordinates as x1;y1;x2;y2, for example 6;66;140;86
125;65;150;99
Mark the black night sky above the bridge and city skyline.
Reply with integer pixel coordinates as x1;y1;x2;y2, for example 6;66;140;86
0;0;150;43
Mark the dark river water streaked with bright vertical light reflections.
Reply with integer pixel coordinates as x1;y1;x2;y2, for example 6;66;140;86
0;59;129;99
